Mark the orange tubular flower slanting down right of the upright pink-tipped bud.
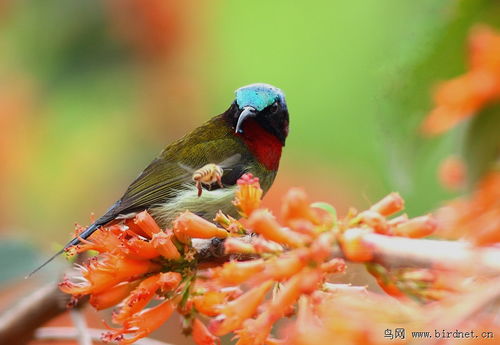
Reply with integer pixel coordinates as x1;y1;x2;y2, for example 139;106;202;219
248;210;306;248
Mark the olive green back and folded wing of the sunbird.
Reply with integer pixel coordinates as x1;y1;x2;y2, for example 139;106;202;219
103;139;245;218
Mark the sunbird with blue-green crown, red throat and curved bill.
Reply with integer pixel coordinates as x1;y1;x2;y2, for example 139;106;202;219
30;83;289;276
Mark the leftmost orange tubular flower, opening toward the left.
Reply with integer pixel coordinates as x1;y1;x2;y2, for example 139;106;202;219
59;253;160;295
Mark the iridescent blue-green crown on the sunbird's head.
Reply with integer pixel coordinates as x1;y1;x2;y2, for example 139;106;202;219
236;83;285;111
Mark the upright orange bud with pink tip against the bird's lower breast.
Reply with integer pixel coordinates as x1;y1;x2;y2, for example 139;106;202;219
233;174;263;217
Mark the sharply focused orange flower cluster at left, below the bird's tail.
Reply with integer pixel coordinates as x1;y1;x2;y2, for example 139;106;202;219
59;207;228;344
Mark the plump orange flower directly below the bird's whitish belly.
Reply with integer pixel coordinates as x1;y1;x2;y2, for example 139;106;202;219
174;211;229;243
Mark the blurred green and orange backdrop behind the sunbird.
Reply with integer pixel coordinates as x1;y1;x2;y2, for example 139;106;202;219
0;0;500;279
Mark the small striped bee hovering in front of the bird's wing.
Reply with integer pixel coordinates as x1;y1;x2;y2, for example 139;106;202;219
179;154;241;197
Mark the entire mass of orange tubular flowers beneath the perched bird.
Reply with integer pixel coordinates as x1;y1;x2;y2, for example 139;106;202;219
60;174;450;345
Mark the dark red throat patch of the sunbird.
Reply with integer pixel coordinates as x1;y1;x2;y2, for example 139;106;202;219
237;119;283;170
